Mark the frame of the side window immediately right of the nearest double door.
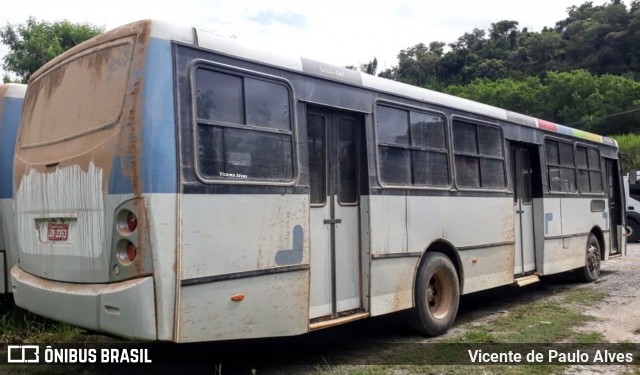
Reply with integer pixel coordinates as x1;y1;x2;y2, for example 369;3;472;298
372;98;454;191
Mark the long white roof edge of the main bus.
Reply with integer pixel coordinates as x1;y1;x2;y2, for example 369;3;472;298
31;20;618;147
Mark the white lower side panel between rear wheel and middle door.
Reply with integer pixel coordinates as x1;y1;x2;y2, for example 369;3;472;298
408;196;515;294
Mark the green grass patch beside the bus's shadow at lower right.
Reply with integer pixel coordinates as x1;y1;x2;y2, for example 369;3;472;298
304;287;607;375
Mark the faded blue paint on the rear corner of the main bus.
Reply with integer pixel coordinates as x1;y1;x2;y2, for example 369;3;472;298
109;38;178;194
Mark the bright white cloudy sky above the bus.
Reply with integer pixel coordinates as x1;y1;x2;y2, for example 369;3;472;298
0;0;616;76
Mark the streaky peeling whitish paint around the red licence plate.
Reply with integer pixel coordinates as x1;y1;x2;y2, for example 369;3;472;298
15;163;110;282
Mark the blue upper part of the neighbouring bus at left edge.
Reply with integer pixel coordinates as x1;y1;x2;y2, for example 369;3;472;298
0;97;24;199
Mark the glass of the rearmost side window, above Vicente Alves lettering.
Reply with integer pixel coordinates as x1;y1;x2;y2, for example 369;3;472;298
194;67;294;182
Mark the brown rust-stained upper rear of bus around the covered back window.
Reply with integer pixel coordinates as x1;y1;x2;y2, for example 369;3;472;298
15;21;151;197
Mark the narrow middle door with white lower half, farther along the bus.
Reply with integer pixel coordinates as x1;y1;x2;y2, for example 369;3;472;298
511;145;536;275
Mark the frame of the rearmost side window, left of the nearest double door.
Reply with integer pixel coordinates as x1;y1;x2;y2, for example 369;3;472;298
188;58;300;186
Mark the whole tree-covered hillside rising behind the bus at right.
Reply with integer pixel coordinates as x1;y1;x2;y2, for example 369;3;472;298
372;0;640;135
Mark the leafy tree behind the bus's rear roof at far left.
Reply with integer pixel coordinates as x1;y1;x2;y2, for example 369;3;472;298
0;17;104;83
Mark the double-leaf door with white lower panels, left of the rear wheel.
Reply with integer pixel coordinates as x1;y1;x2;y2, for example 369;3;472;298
307;109;362;320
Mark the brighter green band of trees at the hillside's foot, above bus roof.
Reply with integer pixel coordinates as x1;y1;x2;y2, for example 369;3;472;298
445;69;640;135
